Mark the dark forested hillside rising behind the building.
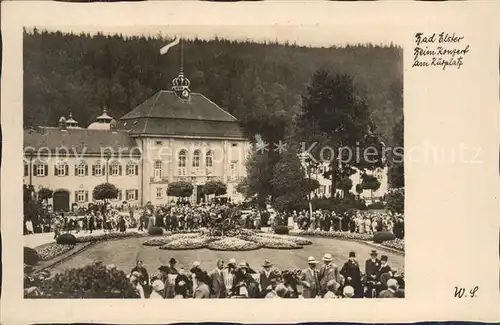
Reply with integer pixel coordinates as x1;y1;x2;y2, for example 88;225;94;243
24;29;403;143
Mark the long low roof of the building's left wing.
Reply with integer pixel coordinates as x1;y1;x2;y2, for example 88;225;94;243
24;127;139;154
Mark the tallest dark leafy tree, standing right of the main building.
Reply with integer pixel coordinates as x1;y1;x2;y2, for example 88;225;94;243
298;70;384;193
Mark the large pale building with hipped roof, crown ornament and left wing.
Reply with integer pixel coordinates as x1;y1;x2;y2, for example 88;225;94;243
24;67;250;210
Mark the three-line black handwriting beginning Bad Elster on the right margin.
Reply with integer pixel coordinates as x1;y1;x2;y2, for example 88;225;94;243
412;32;470;70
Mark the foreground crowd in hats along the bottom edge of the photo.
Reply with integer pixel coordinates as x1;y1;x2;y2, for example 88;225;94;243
129;250;405;299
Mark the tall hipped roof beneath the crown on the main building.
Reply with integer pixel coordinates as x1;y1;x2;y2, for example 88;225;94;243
118;90;243;138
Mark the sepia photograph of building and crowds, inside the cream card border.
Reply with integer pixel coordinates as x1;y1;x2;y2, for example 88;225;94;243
19;25;406;299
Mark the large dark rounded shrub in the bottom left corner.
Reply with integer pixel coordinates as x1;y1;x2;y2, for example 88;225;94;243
39;262;138;299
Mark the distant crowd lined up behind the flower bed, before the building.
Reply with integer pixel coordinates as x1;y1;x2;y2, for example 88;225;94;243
25;202;404;238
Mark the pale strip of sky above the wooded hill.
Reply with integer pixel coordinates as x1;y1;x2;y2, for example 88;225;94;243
32;24;402;47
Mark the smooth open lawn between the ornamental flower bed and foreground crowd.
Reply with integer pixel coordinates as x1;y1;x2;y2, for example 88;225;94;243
48;234;404;273
